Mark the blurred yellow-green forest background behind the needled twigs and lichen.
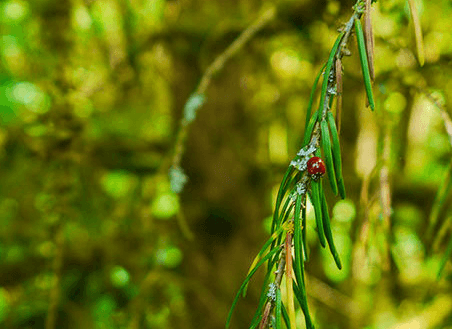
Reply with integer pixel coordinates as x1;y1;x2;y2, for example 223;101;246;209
0;0;452;329
